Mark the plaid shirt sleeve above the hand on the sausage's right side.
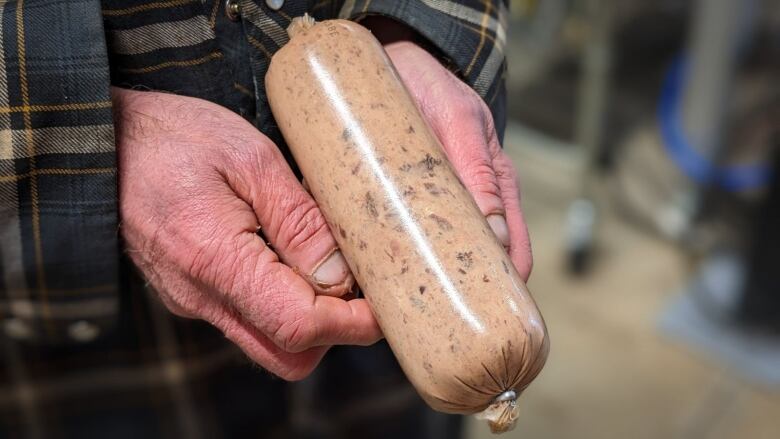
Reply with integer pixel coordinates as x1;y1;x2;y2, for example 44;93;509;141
340;0;508;137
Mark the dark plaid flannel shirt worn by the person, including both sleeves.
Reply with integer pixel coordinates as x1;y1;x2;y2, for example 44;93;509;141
0;0;507;438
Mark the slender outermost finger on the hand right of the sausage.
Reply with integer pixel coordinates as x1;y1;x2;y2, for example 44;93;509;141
493;151;533;282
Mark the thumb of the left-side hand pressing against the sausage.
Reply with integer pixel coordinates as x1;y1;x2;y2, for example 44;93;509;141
221;133;354;296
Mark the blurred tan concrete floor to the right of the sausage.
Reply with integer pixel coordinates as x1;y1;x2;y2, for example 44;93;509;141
467;125;780;439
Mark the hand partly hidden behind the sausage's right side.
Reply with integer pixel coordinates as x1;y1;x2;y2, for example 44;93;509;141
385;41;532;280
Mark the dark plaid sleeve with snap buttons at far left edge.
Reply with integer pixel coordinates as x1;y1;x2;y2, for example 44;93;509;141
0;0;119;344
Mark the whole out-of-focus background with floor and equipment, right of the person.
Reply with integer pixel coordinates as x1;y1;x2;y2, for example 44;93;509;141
467;0;780;439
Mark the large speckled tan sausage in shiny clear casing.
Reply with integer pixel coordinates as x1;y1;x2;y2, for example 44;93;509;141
265;17;549;431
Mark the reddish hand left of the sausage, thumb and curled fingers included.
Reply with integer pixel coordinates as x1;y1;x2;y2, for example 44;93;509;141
112;88;382;380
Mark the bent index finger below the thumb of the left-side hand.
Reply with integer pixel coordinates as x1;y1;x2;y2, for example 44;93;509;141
190;223;382;352
